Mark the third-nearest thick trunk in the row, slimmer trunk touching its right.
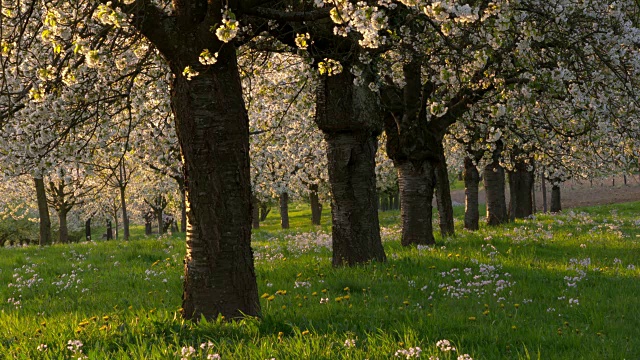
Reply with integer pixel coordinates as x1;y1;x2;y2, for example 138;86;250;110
395;161;435;246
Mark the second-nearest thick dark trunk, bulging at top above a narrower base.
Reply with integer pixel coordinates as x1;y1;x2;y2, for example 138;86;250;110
315;66;386;266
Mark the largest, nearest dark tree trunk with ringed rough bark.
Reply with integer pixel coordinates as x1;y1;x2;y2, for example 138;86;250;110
171;45;260;321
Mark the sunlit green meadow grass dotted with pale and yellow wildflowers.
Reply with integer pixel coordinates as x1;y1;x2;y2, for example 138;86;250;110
0;203;640;359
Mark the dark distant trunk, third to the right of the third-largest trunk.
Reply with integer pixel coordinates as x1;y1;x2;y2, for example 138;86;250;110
483;158;509;225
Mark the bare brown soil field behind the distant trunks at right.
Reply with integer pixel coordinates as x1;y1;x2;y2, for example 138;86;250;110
451;175;640;211
